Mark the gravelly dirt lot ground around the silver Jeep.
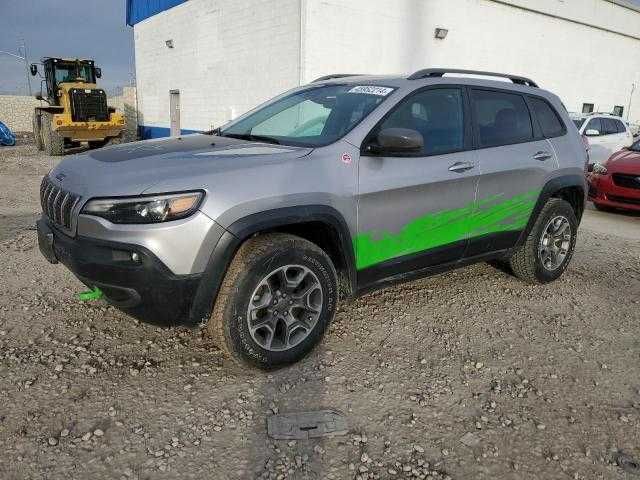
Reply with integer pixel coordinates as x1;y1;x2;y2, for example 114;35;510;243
0;141;640;480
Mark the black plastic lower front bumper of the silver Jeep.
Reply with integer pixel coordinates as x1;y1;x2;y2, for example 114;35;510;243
37;217;204;323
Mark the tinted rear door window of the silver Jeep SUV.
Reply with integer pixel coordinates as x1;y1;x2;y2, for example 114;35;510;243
471;89;533;147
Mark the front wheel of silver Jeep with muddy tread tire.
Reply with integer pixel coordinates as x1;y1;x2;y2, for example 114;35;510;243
207;234;338;370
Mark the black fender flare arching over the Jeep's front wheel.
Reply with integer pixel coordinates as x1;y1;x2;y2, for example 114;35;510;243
189;205;356;325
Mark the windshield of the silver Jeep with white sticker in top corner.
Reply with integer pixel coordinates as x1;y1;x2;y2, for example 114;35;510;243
220;85;395;147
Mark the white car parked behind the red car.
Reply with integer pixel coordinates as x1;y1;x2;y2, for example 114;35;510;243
573;113;633;163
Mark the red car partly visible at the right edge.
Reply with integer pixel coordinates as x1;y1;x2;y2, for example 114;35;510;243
587;140;640;211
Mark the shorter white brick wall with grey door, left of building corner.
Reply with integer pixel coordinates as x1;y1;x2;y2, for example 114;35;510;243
134;0;300;135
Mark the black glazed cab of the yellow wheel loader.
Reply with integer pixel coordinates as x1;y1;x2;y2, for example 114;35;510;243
31;58;101;105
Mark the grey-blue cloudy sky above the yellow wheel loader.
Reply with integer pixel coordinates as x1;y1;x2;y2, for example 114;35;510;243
0;0;135;94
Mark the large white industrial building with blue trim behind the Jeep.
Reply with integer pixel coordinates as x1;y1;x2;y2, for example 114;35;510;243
127;0;640;138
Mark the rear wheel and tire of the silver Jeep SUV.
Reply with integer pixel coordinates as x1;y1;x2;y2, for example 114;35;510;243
509;198;578;283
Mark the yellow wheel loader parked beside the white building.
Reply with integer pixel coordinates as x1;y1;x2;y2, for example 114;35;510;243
30;57;125;155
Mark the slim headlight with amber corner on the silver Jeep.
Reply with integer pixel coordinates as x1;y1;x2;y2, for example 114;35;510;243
81;192;204;223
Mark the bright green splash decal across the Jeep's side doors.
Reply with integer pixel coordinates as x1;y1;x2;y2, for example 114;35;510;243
354;190;540;270
